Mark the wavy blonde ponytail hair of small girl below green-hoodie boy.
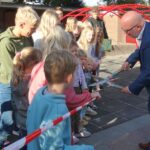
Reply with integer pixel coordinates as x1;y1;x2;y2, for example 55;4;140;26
12;47;42;86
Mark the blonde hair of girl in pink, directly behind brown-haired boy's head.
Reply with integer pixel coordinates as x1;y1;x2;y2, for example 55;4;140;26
42;26;72;58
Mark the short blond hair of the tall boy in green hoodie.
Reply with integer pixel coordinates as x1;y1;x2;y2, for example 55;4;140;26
15;6;40;25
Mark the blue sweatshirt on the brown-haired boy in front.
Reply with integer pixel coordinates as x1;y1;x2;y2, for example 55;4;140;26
27;87;94;150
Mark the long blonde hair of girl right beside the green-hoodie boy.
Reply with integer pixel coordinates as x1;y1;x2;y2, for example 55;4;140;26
38;9;59;36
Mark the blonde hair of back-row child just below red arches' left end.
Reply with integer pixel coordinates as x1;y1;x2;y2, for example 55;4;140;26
65;17;78;32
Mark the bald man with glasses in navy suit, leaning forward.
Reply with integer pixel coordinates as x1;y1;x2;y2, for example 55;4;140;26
121;11;150;150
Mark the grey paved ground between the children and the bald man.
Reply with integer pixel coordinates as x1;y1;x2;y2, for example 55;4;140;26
81;46;150;150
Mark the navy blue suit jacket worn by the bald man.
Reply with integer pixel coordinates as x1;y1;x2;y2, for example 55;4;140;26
127;22;150;95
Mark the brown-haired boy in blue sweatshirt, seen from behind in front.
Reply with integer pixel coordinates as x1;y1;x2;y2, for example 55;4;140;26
27;50;94;150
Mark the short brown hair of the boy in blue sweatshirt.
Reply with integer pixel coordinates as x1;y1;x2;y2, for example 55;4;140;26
44;50;76;84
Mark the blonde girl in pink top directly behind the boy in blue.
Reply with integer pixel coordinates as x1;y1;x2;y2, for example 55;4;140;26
29;26;71;103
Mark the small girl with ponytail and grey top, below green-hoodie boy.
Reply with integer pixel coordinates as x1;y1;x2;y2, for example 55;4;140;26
11;47;42;137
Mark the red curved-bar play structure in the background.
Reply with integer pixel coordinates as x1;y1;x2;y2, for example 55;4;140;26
62;4;150;21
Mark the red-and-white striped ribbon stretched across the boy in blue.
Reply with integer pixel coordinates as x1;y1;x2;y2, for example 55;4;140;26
2;99;95;150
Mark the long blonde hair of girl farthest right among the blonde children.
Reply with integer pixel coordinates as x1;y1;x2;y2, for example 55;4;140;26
78;27;94;51
